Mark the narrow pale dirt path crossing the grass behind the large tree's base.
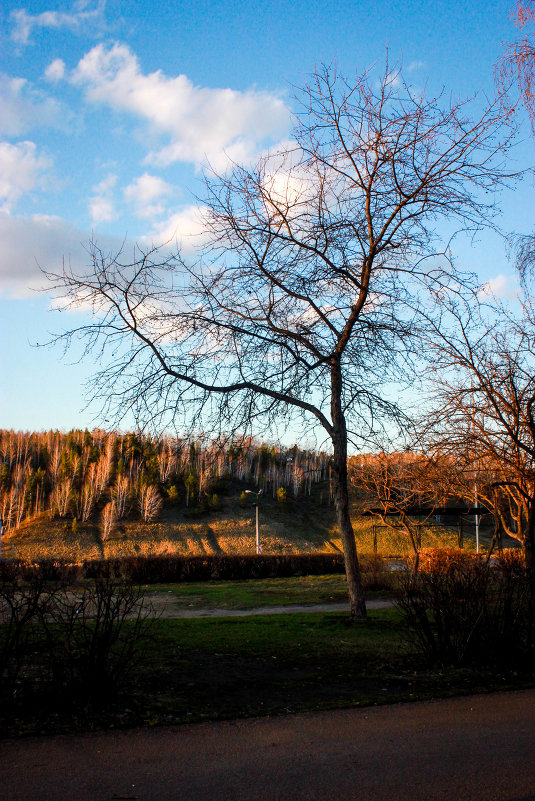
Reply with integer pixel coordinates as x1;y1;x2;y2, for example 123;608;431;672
142;593;393;618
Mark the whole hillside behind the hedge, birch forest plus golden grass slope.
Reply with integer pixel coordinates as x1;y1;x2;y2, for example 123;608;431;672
0;429;498;561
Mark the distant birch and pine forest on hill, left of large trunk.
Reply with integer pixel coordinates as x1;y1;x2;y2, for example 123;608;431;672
0;429;331;535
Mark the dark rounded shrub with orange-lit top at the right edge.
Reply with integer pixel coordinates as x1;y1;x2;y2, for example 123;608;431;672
398;550;535;667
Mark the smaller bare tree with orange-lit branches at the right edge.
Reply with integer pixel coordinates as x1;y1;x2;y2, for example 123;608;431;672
420;282;535;587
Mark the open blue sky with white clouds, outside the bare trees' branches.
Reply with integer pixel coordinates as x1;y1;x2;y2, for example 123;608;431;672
0;0;533;430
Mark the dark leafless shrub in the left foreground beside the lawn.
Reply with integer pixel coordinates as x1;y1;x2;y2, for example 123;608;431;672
0;563;150;713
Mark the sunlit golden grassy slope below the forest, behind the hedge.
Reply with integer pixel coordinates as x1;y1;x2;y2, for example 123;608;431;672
3;482;474;561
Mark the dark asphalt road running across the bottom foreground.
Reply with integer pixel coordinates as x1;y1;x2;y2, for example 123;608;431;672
0;690;535;801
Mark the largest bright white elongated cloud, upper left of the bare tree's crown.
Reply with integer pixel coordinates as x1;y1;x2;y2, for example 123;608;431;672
71;43;290;169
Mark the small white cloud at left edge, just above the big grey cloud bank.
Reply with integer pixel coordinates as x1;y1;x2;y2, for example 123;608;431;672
0;142;51;213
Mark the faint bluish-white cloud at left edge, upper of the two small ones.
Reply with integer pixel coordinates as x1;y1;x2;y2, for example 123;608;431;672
0;75;66;136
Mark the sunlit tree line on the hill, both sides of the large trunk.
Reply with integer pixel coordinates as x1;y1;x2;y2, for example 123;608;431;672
0;429;529;568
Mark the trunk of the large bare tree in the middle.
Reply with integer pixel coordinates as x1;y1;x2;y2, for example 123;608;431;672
331;365;367;620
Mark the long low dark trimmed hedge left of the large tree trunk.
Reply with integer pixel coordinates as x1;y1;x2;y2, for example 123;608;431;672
0;553;344;584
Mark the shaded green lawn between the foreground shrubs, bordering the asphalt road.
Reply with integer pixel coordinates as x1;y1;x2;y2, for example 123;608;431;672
0;609;533;735
